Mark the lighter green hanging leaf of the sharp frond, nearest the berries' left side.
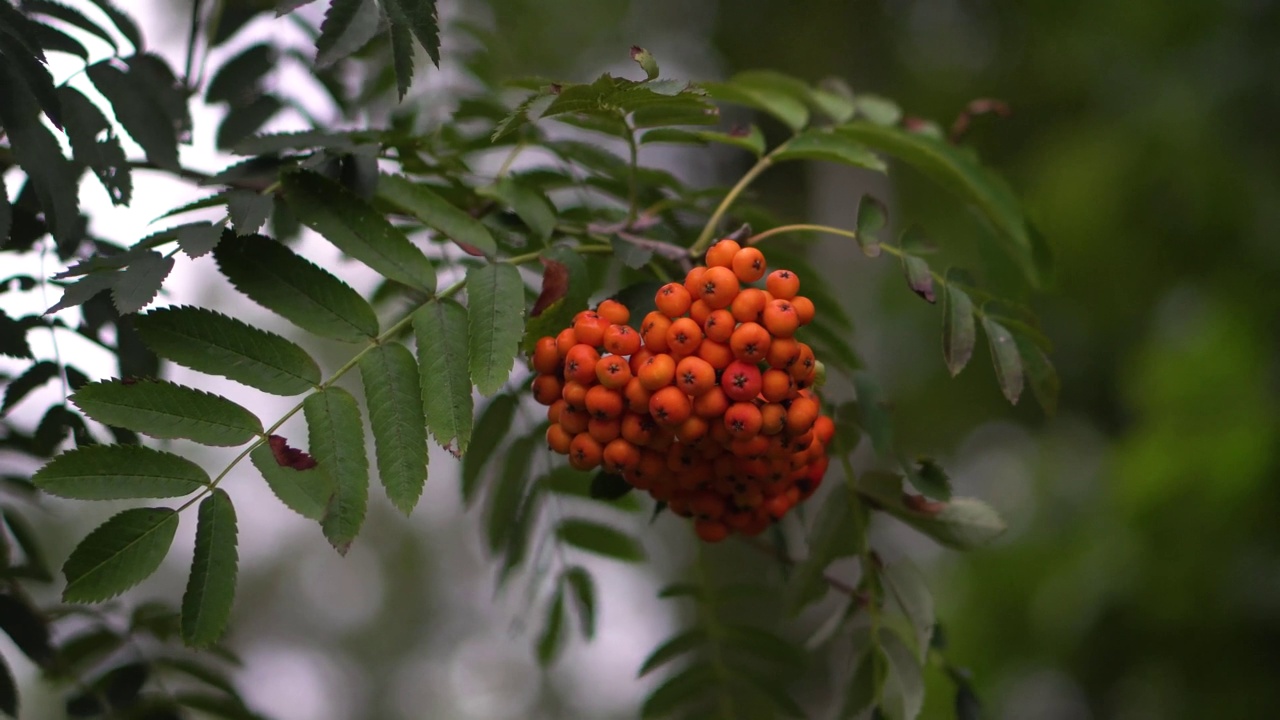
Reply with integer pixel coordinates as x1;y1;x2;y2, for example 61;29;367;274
467;264;525;396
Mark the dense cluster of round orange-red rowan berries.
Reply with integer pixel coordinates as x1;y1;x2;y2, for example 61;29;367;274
532;240;836;542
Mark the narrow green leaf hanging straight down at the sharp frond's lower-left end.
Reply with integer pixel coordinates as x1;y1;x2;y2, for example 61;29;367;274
182;489;239;647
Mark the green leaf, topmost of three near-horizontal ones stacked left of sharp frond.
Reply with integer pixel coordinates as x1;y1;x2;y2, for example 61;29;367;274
133;306;320;395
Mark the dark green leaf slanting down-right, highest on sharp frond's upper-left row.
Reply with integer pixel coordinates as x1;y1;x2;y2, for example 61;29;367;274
282;170;435;292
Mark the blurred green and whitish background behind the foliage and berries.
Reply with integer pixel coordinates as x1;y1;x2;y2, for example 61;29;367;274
5;0;1280;720
